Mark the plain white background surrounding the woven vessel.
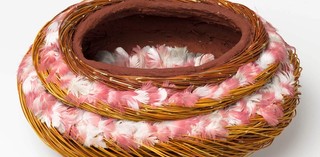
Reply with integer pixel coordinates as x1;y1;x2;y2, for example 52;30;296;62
0;0;320;157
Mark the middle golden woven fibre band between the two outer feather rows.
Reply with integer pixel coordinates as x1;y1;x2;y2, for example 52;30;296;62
32;1;279;121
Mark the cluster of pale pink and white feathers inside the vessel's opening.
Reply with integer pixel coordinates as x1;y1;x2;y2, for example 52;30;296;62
105;45;214;69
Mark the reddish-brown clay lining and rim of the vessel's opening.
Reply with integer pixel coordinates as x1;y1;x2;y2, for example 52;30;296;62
73;0;252;77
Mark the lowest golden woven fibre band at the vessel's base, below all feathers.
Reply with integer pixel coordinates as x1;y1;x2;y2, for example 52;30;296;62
18;53;301;157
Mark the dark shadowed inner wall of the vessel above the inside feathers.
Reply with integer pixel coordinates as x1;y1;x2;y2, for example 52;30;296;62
82;14;241;59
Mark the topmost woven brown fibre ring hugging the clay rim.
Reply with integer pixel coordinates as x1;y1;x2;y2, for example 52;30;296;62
60;0;268;90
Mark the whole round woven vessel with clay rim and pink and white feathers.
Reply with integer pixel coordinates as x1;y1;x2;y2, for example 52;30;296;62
18;0;301;157
